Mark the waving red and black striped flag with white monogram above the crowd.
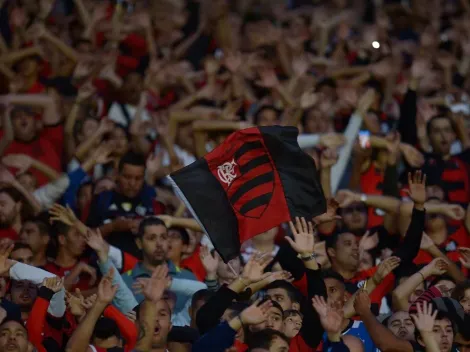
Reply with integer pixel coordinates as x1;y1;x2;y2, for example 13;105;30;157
168;126;326;262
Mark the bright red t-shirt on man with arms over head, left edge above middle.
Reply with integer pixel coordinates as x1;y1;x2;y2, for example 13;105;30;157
0;125;64;186
